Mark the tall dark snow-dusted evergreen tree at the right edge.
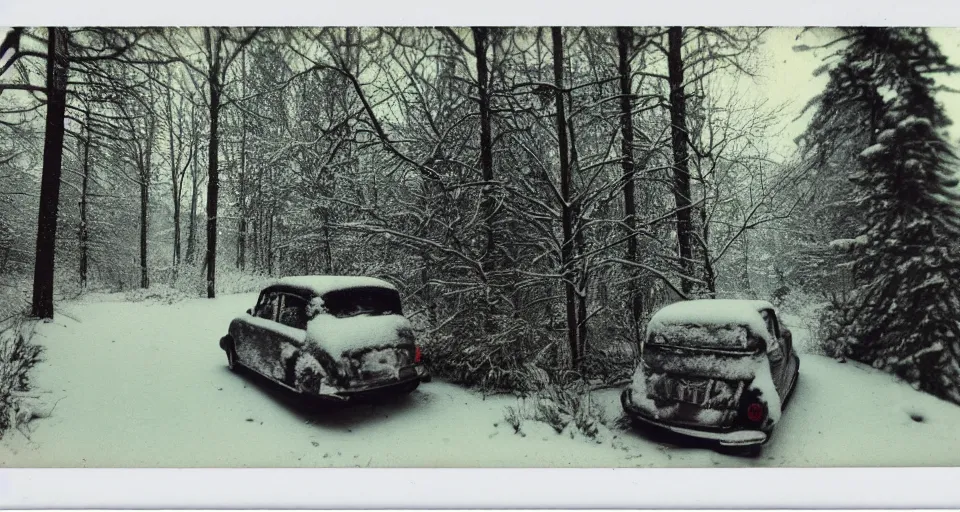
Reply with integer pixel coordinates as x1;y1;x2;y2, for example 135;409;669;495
812;28;960;403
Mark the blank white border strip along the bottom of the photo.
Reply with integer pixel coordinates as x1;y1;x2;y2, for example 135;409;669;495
0;468;960;509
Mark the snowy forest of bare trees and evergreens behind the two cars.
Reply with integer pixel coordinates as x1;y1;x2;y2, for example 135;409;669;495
0;27;960;431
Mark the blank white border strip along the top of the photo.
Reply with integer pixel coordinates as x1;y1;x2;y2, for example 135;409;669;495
0;0;960;27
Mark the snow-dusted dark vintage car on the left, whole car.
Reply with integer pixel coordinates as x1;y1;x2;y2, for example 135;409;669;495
220;276;430;401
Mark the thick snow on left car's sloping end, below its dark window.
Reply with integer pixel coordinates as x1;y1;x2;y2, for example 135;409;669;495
307;315;413;359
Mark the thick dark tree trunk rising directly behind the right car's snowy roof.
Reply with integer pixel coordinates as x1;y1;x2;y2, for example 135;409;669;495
667;27;693;294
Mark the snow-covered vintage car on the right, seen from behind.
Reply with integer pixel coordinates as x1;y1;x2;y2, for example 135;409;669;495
620;299;800;453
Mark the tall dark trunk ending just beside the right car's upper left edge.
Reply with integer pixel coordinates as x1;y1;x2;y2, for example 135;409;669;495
617;27;643;341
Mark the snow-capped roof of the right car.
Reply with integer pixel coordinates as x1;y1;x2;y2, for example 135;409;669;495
647;299;774;337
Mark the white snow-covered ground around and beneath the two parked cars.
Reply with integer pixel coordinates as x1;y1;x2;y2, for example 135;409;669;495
0;294;960;467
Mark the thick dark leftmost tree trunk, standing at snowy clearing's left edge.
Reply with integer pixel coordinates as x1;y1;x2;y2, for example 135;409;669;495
31;27;70;319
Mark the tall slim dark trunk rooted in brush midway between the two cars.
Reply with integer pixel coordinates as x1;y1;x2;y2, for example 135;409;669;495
550;27;580;370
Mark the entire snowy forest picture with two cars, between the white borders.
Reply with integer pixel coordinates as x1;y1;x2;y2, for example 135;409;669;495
0;3;960;476
